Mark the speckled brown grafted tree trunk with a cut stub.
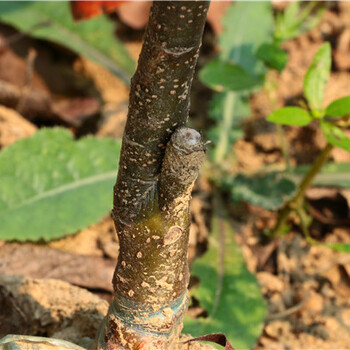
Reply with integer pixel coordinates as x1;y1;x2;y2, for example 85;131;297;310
98;1;209;350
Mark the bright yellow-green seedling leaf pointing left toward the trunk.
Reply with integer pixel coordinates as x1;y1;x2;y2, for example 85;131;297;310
267;107;312;126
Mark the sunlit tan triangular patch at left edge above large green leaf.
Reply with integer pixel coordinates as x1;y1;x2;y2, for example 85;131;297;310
0;106;37;149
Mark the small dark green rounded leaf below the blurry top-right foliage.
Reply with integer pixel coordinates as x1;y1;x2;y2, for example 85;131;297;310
256;43;288;72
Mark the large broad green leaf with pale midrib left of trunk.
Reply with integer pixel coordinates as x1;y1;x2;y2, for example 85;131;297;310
0;128;120;241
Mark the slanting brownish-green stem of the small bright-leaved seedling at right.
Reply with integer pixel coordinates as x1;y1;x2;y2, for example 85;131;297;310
270;144;333;238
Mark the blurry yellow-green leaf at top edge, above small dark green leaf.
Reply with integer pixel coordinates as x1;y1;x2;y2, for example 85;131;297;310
275;1;325;42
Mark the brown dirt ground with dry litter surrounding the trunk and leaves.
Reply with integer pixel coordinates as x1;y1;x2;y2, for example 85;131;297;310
0;1;350;350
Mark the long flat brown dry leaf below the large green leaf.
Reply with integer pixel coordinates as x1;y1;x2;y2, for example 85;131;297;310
0;243;116;292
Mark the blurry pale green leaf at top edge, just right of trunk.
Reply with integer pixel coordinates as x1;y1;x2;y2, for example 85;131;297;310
219;1;274;77
